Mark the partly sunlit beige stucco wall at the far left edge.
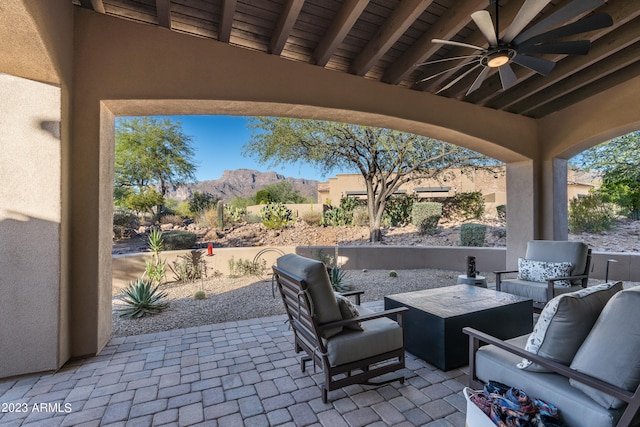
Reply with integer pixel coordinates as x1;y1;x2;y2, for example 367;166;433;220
0;75;66;378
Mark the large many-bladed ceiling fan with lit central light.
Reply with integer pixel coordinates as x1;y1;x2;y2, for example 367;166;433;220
416;0;613;95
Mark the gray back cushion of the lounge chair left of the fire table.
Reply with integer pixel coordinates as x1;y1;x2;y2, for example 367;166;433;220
277;254;342;338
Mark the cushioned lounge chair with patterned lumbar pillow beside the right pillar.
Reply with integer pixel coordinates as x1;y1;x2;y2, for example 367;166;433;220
494;240;591;310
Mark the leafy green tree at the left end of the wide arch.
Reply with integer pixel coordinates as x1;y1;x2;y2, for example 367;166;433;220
114;117;196;213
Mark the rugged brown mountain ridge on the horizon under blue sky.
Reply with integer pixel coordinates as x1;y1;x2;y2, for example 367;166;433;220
162;169;318;202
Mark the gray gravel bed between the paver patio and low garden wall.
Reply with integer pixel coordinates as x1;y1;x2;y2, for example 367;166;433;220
112;269;494;337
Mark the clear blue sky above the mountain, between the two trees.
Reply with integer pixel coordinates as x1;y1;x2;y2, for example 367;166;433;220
139;116;352;181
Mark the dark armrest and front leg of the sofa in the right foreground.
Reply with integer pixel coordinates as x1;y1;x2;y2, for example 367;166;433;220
462;327;640;406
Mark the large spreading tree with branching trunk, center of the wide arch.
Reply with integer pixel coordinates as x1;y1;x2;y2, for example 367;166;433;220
244;117;491;242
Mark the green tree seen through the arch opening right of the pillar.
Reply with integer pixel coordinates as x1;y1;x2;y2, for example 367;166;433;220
576;131;640;220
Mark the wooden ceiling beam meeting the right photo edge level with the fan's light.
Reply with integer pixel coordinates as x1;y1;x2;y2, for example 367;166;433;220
508;42;640;115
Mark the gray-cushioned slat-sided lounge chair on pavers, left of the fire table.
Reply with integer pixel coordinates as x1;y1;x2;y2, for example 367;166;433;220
273;254;407;403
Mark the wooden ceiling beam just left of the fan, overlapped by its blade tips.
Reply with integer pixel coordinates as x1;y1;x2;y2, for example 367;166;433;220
382;0;489;85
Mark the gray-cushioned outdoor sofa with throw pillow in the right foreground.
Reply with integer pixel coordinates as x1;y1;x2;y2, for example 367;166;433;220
464;282;640;427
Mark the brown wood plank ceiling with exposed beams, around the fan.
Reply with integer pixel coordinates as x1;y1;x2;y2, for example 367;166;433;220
72;0;640;118
